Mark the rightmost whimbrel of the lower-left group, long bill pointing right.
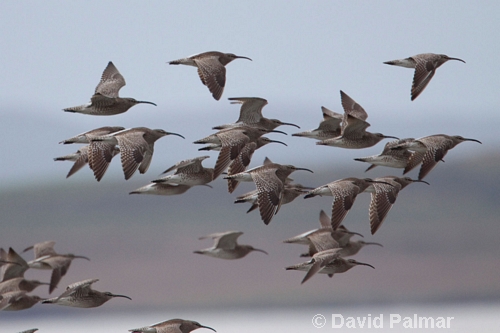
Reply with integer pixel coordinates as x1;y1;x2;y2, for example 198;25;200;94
42;279;132;308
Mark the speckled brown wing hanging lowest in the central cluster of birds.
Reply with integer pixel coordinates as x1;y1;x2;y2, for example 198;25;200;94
252;168;284;224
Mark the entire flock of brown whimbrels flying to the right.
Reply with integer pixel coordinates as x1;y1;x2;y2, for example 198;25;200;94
0;52;481;333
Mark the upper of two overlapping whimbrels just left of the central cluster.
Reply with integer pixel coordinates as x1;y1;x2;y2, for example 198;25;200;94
152;156;214;186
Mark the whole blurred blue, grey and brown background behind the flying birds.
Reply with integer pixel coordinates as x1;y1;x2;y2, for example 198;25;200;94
0;1;500;333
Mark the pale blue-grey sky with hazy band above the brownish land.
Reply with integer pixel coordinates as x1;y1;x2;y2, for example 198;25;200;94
0;1;500;185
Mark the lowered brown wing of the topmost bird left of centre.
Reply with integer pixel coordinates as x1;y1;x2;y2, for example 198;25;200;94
195;55;226;100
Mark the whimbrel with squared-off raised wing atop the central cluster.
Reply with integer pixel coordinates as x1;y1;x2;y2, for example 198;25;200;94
212;97;300;130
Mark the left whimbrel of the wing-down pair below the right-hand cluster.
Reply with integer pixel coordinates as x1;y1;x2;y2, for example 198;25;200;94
304;177;390;230
